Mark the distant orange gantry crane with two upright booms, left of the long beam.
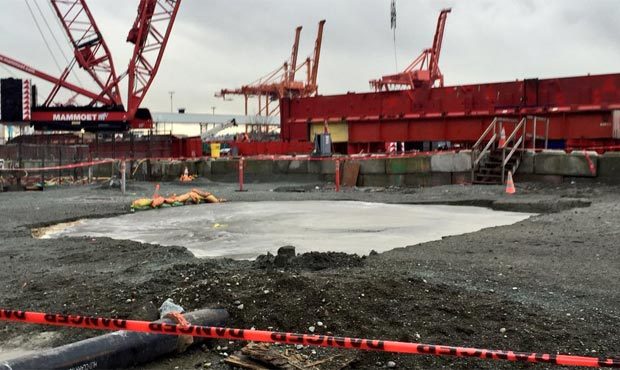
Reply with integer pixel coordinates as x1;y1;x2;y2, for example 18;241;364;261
215;20;325;116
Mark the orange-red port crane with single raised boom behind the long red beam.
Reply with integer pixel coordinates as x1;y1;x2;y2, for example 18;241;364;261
370;9;451;91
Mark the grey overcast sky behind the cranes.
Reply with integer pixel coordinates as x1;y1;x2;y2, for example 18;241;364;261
0;0;620;113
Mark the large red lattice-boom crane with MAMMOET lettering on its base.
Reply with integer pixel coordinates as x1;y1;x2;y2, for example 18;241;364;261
0;0;181;131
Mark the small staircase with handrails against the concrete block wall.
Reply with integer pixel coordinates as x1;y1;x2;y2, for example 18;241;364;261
471;116;549;185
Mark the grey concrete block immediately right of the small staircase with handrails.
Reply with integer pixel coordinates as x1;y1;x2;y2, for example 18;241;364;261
534;151;598;177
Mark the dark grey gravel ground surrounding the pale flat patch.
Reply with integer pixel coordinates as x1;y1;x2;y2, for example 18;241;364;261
0;180;620;369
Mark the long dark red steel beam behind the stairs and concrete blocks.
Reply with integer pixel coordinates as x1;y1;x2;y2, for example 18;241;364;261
280;74;620;147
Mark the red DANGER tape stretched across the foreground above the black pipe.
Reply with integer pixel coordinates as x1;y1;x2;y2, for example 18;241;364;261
0;309;620;368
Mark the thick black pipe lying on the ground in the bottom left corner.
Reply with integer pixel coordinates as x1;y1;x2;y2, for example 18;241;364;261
0;309;228;370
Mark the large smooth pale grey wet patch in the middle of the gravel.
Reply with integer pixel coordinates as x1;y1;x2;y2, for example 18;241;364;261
39;201;532;259
